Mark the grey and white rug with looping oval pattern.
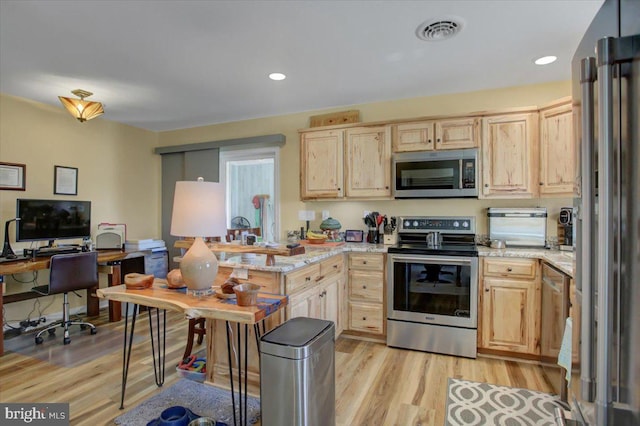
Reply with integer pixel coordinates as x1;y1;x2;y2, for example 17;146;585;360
444;378;567;426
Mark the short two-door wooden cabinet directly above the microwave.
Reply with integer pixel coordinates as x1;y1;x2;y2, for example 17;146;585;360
393;117;481;152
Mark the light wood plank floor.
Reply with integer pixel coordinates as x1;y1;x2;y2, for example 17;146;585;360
0;312;551;426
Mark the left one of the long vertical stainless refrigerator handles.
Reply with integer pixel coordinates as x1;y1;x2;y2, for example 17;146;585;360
576;57;597;402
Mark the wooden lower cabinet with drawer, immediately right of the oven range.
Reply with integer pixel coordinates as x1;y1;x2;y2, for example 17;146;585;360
479;258;541;355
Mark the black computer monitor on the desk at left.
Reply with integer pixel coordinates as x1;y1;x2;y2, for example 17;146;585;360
16;198;91;245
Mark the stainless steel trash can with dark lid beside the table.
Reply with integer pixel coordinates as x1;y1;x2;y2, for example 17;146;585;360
260;317;336;426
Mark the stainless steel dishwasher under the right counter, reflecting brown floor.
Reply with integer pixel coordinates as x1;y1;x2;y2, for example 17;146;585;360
540;262;570;401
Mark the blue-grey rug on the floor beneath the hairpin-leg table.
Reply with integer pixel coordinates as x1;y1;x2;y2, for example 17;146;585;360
114;379;260;426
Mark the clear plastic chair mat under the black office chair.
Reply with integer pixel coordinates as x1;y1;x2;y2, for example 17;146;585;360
4;326;142;367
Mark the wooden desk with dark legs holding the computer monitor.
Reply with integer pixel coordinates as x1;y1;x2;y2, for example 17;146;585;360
0;250;151;356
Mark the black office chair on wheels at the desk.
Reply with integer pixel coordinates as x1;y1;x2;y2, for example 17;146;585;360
32;252;98;345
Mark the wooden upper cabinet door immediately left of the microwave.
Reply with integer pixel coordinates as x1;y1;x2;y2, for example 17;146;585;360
344;126;391;198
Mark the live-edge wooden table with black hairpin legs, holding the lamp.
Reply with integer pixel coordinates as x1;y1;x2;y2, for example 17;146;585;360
97;284;288;424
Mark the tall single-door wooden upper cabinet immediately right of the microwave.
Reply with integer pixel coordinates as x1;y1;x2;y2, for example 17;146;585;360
480;112;538;198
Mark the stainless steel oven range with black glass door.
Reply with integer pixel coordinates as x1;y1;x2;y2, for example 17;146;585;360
387;216;478;358
